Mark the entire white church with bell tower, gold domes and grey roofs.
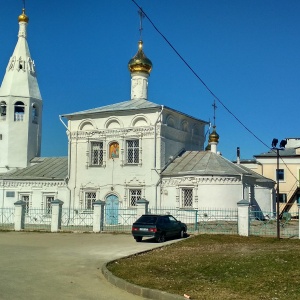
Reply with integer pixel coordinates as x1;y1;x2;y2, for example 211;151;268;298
0;10;275;211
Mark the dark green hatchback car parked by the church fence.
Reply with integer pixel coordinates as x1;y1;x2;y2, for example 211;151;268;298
131;215;187;243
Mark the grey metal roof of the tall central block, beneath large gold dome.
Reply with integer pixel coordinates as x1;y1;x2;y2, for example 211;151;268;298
62;99;208;124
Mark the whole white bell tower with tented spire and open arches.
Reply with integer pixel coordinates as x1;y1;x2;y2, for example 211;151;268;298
0;8;43;173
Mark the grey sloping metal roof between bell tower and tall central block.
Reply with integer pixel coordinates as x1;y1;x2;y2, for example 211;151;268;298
0;157;68;180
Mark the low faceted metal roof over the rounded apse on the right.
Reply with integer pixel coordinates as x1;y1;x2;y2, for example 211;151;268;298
162;151;272;182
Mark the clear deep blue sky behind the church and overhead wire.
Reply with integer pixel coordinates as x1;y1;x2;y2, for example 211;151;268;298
0;0;300;160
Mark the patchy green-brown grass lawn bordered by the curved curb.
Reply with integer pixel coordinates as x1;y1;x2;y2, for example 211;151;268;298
108;235;300;300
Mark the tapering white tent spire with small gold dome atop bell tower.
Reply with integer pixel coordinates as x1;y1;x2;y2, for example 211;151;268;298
0;9;42;99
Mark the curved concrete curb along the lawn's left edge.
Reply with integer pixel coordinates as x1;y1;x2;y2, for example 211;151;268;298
101;260;185;300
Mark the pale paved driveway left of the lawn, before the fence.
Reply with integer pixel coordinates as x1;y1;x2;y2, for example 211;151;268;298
0;232;172;300
